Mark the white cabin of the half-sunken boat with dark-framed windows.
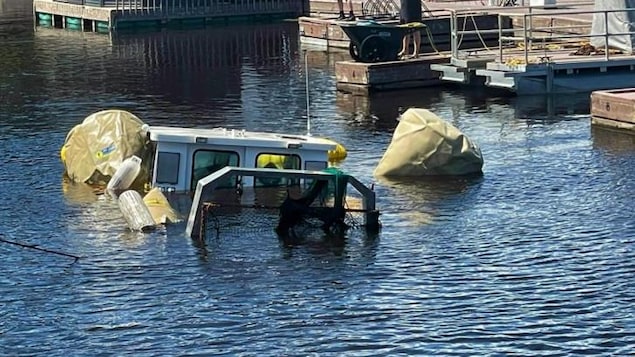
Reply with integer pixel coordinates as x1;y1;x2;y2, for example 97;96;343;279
148;126;337;192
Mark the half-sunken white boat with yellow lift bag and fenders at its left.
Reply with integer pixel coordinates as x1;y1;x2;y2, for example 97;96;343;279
60;110;379;236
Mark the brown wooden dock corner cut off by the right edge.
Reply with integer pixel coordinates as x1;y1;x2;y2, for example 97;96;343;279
591;88;635;131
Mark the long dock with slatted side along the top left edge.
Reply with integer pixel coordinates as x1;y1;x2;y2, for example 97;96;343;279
33;0;306;32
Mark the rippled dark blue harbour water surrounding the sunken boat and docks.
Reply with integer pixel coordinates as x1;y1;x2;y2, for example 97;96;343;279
0;0;635;356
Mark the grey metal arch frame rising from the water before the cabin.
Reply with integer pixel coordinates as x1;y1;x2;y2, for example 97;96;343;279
186;166;379;239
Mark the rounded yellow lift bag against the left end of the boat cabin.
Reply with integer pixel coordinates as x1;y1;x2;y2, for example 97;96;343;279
60;110;148;184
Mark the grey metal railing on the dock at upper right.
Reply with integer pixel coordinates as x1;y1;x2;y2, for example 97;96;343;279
450;2;635;65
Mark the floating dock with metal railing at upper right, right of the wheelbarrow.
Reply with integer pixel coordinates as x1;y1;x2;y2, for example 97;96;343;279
431;2;635;95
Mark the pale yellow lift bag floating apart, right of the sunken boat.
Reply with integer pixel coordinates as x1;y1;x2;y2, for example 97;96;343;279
375;108;483;176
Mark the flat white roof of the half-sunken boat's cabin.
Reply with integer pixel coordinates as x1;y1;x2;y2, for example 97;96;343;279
148;126;337;151
